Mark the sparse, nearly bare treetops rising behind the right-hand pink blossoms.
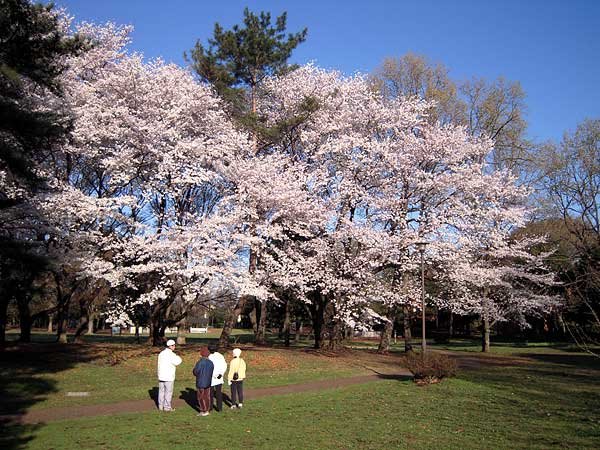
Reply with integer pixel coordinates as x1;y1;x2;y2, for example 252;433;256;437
371;53;532;173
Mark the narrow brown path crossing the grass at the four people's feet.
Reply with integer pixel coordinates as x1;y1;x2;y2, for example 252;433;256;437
0;370;412;424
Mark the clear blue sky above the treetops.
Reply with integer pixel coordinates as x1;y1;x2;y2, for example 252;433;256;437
55;0;600;140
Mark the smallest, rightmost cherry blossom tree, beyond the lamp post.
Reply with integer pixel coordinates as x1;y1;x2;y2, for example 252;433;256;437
436;172;559;352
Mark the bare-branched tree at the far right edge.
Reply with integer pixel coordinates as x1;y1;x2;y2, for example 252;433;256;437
536;119;600;353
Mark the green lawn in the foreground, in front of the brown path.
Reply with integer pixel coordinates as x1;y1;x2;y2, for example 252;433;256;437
5;363;600;450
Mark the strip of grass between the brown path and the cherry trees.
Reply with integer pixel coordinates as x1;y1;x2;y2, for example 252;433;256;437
0;335;372;413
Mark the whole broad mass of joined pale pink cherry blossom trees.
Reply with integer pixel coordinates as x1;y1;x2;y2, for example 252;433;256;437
17;11;556;347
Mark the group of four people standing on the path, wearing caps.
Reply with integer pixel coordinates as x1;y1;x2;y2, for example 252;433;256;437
158;339;246;416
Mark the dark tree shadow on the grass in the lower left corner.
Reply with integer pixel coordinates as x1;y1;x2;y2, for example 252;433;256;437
0;344;96;450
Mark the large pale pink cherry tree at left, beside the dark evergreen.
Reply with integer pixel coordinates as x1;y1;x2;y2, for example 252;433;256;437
34;20;260;343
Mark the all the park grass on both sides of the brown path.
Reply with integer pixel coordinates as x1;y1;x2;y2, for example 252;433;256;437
0;332;600;449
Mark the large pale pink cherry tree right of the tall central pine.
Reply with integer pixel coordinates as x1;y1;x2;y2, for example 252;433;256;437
253;66;556;352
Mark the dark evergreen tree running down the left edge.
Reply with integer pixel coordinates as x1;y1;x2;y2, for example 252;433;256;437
0;0;83;342
